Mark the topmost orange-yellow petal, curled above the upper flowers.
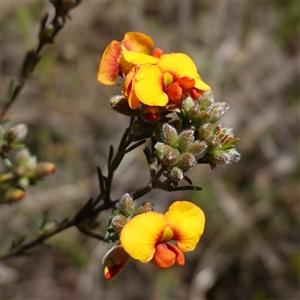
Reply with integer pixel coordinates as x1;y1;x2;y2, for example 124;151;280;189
122;32;153;54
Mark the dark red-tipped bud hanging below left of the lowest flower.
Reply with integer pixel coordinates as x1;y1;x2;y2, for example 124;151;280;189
102;245;129;280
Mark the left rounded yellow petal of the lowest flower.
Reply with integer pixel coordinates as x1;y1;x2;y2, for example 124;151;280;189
120;212;166;263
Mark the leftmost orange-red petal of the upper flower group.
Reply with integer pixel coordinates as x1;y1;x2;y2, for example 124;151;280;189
97;41;121;85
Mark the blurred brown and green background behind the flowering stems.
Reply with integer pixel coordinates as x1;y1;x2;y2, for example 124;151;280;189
1;0;300;300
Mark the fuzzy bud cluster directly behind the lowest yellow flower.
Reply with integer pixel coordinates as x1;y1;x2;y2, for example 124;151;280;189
108;193;153;239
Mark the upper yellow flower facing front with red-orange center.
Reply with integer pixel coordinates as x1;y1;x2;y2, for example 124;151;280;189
123;53;210;109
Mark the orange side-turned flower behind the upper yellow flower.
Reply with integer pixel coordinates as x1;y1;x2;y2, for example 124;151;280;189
97;32;153;85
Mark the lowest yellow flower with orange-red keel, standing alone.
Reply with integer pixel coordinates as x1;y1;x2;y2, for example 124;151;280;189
120;201;205;269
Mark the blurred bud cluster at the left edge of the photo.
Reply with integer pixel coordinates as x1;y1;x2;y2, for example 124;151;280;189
0;124;56;203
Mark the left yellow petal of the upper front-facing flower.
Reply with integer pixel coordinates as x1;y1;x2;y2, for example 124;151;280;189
134;64;169;106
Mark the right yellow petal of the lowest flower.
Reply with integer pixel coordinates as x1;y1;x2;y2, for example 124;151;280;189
165;201;205;252
